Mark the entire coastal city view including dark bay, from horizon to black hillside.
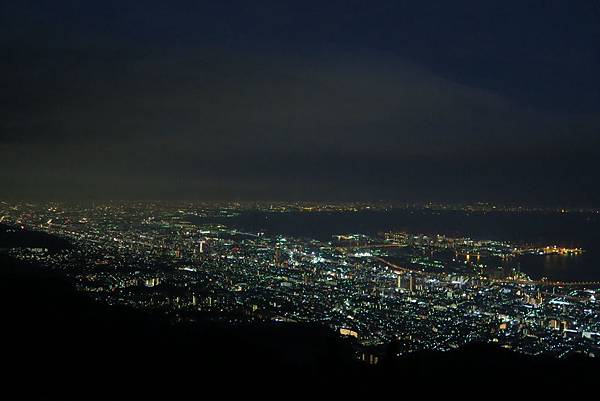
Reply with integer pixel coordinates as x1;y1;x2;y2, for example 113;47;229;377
0;203;600;362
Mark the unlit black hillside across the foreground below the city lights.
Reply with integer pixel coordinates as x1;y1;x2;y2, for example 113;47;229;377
0;256;600;399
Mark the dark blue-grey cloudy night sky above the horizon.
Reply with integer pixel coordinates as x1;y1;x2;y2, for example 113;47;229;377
0;0;600;206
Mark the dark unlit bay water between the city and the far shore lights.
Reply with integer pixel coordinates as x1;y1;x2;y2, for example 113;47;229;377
190;209;600;281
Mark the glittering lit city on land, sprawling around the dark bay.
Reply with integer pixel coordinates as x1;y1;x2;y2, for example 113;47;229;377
1;202;600;363
